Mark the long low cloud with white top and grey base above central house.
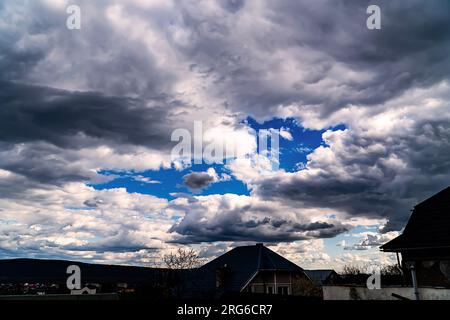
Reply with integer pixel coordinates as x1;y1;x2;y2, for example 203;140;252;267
170;194;350;243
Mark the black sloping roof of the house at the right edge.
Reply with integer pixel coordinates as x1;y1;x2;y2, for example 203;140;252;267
380;187;450;251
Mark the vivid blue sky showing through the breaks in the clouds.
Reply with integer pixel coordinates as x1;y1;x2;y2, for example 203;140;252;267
91;118;345;200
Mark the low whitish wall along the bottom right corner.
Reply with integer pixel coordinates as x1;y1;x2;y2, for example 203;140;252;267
323;286;450;300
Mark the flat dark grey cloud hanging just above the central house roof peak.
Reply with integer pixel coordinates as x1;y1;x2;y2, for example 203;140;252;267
169;199;350;243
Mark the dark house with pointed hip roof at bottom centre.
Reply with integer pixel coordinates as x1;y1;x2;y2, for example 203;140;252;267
189;244;310;296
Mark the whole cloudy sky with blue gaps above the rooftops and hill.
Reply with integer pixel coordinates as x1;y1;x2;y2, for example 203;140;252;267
0;0;450;268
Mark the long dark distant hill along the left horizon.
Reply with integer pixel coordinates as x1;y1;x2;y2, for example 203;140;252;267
0;259;173;284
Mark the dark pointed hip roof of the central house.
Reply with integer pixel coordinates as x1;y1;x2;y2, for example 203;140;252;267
199;244;303;291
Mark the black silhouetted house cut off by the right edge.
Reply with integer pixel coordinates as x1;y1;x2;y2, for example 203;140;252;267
381;187;450;287
